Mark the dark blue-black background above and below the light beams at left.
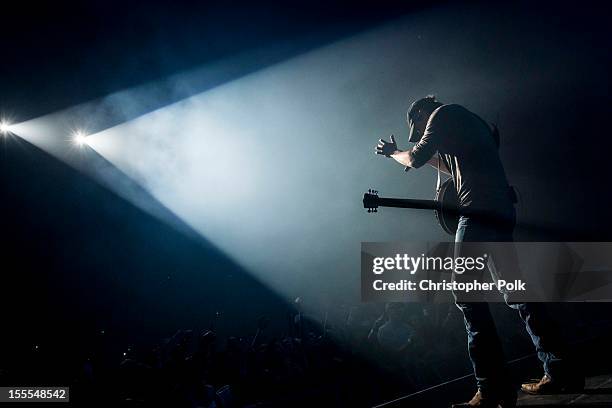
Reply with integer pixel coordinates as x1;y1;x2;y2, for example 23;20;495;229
0;1;444;372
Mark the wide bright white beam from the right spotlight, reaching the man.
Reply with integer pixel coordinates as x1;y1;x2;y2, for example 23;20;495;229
89;16;450;310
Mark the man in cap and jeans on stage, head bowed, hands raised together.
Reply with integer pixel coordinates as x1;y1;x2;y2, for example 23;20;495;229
376;96;584;408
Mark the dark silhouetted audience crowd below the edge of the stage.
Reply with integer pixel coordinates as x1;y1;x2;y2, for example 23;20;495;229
1;299;469;408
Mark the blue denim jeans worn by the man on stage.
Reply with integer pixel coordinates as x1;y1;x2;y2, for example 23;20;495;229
455;215;567;392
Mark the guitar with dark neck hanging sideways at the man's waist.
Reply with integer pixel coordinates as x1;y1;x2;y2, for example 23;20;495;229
363;179;460;235
